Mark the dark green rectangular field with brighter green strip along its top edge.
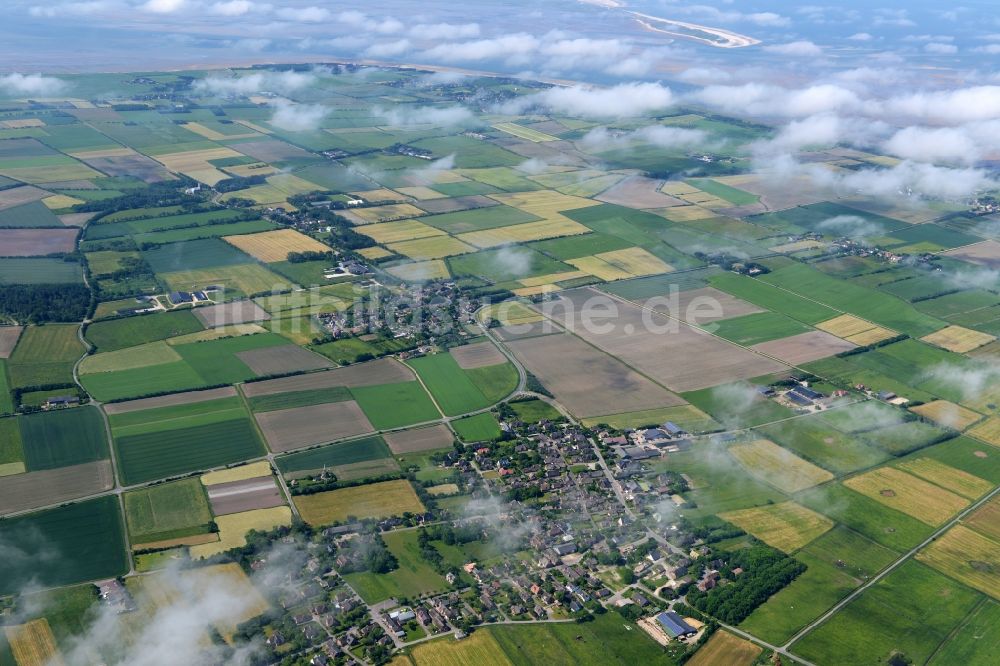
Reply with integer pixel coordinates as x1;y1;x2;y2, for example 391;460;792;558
115;418;265;485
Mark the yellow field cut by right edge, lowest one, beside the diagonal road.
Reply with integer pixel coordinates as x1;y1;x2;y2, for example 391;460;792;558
917;525;1000;599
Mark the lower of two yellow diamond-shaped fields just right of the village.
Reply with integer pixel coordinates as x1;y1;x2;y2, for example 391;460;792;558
719;501;833;553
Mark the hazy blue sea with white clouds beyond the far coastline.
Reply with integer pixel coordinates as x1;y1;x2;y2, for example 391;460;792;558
0;0;1000;197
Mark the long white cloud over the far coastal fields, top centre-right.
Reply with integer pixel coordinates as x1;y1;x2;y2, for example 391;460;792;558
507;83;675;118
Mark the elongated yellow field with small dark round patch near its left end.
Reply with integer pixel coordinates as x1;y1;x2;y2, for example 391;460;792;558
844;467;969;526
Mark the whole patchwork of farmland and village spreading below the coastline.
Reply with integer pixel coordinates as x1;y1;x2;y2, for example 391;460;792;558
0;50;1000;666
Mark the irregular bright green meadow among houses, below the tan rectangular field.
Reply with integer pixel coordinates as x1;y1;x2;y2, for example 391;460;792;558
344;530;450;604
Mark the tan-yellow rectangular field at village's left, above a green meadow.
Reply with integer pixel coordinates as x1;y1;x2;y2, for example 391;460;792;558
294;479;424;525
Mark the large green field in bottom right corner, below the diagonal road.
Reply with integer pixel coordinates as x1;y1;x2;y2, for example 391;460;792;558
792;561;982;664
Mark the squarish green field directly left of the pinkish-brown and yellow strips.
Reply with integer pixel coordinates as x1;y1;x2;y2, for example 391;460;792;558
123;478;212;544
